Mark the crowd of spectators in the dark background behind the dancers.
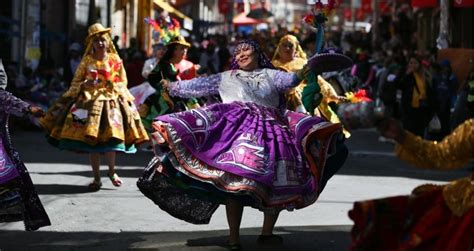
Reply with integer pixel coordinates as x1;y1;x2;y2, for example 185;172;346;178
4;24;473;140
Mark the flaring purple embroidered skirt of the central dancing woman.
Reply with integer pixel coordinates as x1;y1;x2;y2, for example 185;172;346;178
138;102;342;224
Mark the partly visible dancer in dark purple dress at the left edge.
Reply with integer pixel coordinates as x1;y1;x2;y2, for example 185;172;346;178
0;59;51;229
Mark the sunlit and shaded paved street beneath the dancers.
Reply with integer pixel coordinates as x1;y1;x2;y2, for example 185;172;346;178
0;126;468;251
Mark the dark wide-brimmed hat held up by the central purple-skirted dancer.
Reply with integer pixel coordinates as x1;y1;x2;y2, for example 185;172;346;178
307;53;354;74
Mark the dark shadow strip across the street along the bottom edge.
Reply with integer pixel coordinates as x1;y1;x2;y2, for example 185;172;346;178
0;225;350;251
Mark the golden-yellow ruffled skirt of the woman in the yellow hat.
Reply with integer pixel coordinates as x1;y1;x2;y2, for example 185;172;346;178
40;92;148;153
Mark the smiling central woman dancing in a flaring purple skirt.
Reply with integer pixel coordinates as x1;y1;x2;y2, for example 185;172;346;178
138;40;347;249
